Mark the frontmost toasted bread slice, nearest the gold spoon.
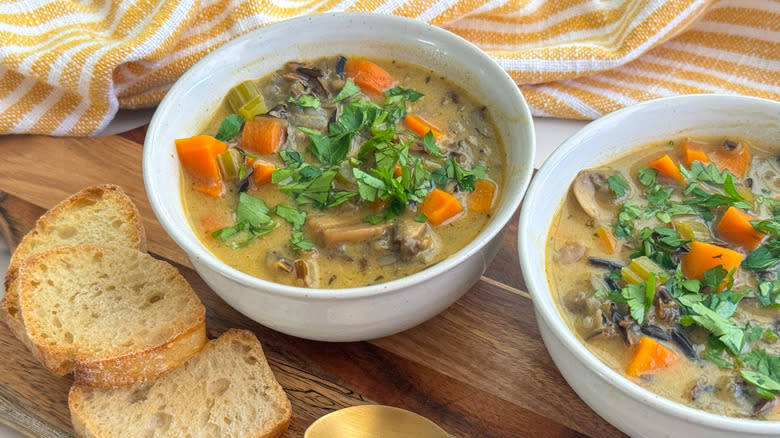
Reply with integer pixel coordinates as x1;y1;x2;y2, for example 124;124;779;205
68;329;292;438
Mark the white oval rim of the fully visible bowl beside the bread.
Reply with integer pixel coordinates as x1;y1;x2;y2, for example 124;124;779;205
142;12;536;301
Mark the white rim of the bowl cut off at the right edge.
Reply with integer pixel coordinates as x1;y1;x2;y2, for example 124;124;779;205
517;94;780;436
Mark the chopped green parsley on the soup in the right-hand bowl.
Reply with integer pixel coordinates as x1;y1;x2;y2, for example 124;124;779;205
584;144;780;398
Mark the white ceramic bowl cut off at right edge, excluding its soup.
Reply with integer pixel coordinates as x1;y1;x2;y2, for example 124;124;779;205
518;95;780;438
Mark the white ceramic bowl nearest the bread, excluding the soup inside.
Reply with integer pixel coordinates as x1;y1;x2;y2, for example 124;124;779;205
143;13;534;341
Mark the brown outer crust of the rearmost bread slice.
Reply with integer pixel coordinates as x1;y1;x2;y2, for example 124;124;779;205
0;184;147;348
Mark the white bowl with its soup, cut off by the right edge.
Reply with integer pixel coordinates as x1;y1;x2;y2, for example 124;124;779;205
519;95;780;437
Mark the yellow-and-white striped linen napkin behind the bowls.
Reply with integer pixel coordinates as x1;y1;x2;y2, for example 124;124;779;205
0;0;780;136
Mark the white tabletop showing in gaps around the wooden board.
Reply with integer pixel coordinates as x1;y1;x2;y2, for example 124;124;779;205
0;114;587;438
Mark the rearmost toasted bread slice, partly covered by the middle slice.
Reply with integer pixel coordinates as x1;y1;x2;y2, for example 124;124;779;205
0;185;146;347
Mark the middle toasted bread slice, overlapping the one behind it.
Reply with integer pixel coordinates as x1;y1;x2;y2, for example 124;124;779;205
17;245;206;387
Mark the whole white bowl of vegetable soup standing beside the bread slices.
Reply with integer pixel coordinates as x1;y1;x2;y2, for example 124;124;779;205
144;13;534;341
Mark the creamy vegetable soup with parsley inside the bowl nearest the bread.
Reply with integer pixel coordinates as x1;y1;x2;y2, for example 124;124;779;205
175;55;506;289
